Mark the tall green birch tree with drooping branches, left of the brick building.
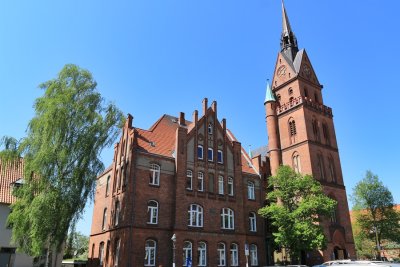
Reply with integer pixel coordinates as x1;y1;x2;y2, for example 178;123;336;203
0;65;123;264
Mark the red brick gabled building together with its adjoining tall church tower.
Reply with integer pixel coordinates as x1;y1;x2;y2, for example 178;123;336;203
88;3;355;266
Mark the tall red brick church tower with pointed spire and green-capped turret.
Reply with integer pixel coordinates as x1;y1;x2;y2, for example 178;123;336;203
264;1;356;265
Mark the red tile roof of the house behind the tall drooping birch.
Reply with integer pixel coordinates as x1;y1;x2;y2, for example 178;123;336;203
0;159;24;204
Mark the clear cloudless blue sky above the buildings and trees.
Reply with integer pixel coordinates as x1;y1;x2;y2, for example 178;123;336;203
0;0;400;235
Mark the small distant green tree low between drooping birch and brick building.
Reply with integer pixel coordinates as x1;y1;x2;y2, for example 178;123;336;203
64;231;89;259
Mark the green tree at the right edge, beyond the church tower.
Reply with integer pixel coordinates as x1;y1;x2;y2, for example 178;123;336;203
351;171;400;257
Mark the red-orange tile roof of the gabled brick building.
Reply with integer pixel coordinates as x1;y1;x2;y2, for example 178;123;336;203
134;114;258;175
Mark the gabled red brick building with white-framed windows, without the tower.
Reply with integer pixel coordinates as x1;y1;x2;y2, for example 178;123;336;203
89;104;266;266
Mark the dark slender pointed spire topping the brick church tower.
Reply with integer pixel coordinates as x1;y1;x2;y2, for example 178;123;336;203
281;0;299;62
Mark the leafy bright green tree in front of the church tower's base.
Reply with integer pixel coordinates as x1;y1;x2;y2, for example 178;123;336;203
259;166;336;262
